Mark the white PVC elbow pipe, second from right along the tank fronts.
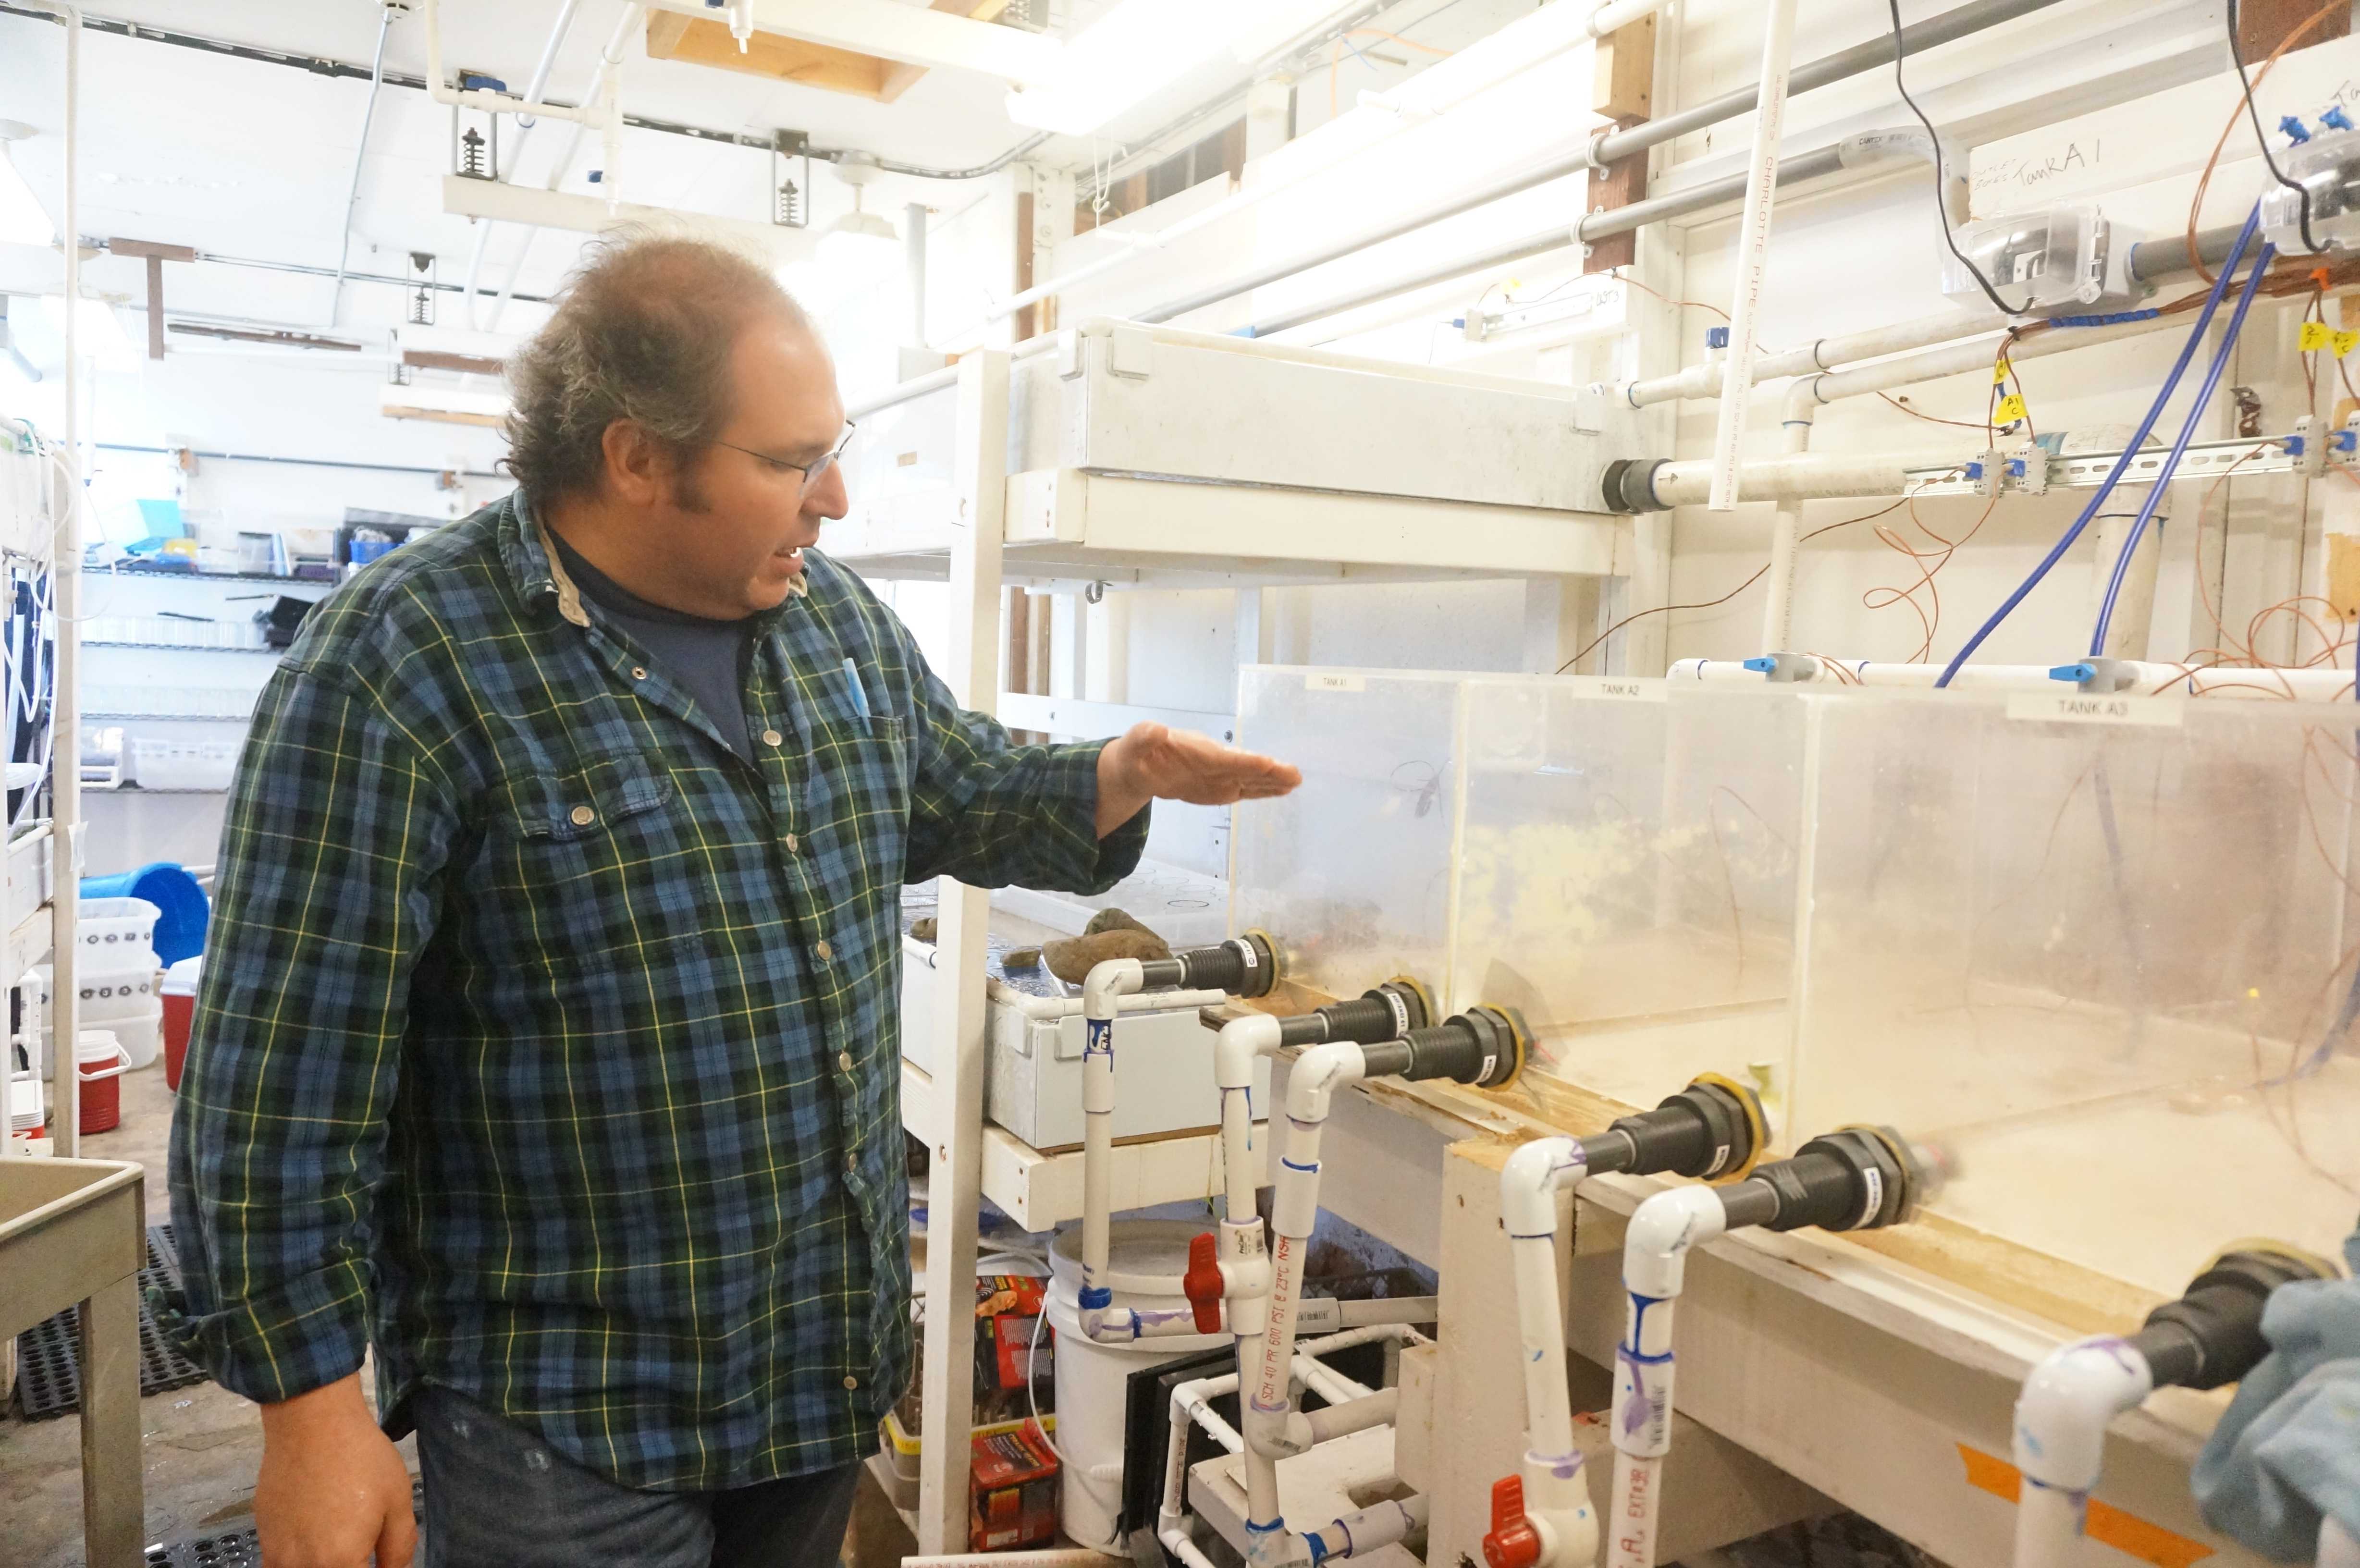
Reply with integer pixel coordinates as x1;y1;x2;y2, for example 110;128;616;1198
1607;1188;1728;1568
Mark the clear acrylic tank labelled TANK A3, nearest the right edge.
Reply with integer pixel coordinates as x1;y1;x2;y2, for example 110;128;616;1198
1794;692;2360;1297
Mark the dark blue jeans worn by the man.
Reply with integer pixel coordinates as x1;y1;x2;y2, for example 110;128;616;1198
411;1388;861;1568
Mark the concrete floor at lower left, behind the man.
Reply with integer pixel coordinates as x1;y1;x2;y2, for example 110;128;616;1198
0;1063;418;1568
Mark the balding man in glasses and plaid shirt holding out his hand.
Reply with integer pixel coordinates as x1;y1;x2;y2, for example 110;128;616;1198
172;238;1298;1568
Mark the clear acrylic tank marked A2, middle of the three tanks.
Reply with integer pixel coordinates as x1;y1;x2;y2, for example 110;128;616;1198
1447;675;1806;1127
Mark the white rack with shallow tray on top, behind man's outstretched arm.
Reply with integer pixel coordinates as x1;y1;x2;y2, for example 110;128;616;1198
873;321;1638;1554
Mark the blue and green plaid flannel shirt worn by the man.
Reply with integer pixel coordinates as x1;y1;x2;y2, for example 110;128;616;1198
170;498;1147;1490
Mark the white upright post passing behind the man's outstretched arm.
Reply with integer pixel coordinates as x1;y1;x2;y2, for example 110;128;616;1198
918;350;1008;1556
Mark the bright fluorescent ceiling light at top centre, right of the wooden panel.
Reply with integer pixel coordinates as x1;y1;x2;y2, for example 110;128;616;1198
1008;0;1340;137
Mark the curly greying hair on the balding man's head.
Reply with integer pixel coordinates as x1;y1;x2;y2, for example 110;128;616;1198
503;232;812;510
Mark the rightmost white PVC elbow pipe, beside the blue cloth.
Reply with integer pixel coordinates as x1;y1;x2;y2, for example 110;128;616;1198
2013;1334;2155;1568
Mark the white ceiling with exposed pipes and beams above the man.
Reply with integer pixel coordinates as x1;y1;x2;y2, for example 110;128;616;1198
0;0;1491;368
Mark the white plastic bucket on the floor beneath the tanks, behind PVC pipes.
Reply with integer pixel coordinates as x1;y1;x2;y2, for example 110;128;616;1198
1048;1218;1234;1556
